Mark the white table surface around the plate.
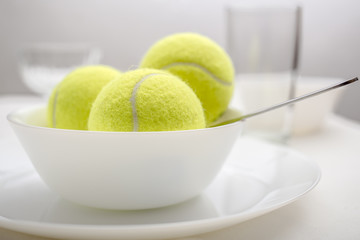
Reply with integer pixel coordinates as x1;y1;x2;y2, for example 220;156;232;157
0;96;360;240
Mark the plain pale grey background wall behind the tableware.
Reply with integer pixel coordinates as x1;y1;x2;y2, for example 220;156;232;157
0;0;360;121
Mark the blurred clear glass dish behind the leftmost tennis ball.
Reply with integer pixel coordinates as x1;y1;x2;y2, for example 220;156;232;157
19;43;102;98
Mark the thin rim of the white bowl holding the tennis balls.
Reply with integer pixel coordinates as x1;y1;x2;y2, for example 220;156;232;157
6;104;244;136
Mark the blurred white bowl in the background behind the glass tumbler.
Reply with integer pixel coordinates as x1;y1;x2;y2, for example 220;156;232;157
232;75;345;136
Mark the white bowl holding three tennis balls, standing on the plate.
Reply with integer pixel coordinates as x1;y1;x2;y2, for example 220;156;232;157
8;106;243;210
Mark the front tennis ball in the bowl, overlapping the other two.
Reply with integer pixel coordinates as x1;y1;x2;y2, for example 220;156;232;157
88;69;205;132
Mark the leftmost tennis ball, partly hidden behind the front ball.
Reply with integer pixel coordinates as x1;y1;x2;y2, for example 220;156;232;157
47;65;120;130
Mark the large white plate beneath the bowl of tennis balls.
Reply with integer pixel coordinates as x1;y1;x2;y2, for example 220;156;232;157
0;138;320;240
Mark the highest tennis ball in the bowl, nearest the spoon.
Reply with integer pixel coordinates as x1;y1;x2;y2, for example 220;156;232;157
140;33;234;124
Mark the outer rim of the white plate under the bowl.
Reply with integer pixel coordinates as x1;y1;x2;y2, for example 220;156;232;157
0;137;322;240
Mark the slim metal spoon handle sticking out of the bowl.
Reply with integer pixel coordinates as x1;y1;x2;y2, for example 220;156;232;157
209;77;359;127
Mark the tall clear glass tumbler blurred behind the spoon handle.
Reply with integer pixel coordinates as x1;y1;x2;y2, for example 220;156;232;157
226;2;301;142
